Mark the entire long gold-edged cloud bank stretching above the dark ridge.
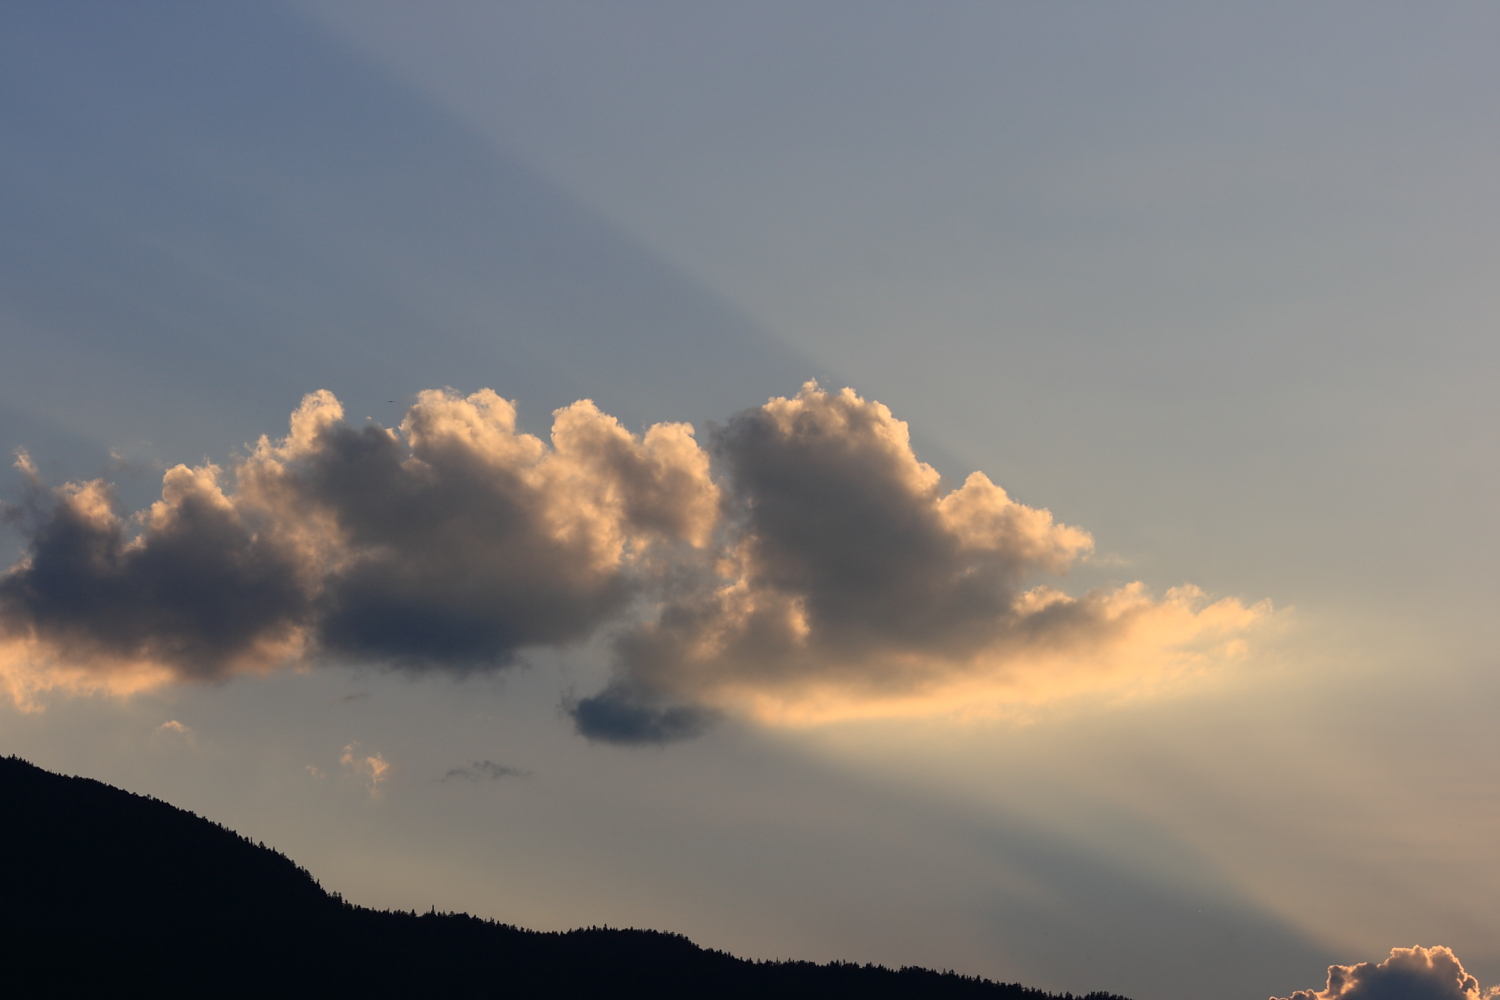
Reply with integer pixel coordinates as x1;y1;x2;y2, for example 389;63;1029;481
0;382;1271;742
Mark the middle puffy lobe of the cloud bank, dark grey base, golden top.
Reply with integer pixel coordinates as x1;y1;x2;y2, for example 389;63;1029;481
255;391;713;666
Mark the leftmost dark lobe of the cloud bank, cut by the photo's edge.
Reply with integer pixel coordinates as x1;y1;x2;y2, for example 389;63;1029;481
0;455;305;700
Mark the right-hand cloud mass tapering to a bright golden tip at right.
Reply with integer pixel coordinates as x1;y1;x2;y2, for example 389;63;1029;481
573;382;1269;742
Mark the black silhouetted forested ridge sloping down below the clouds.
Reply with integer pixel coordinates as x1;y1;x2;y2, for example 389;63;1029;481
0;757;1125;1000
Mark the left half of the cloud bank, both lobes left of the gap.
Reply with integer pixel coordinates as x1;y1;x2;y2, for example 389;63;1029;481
0;390;717;702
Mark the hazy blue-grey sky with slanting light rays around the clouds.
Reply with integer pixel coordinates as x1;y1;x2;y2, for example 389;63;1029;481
0;0;1500;1000
